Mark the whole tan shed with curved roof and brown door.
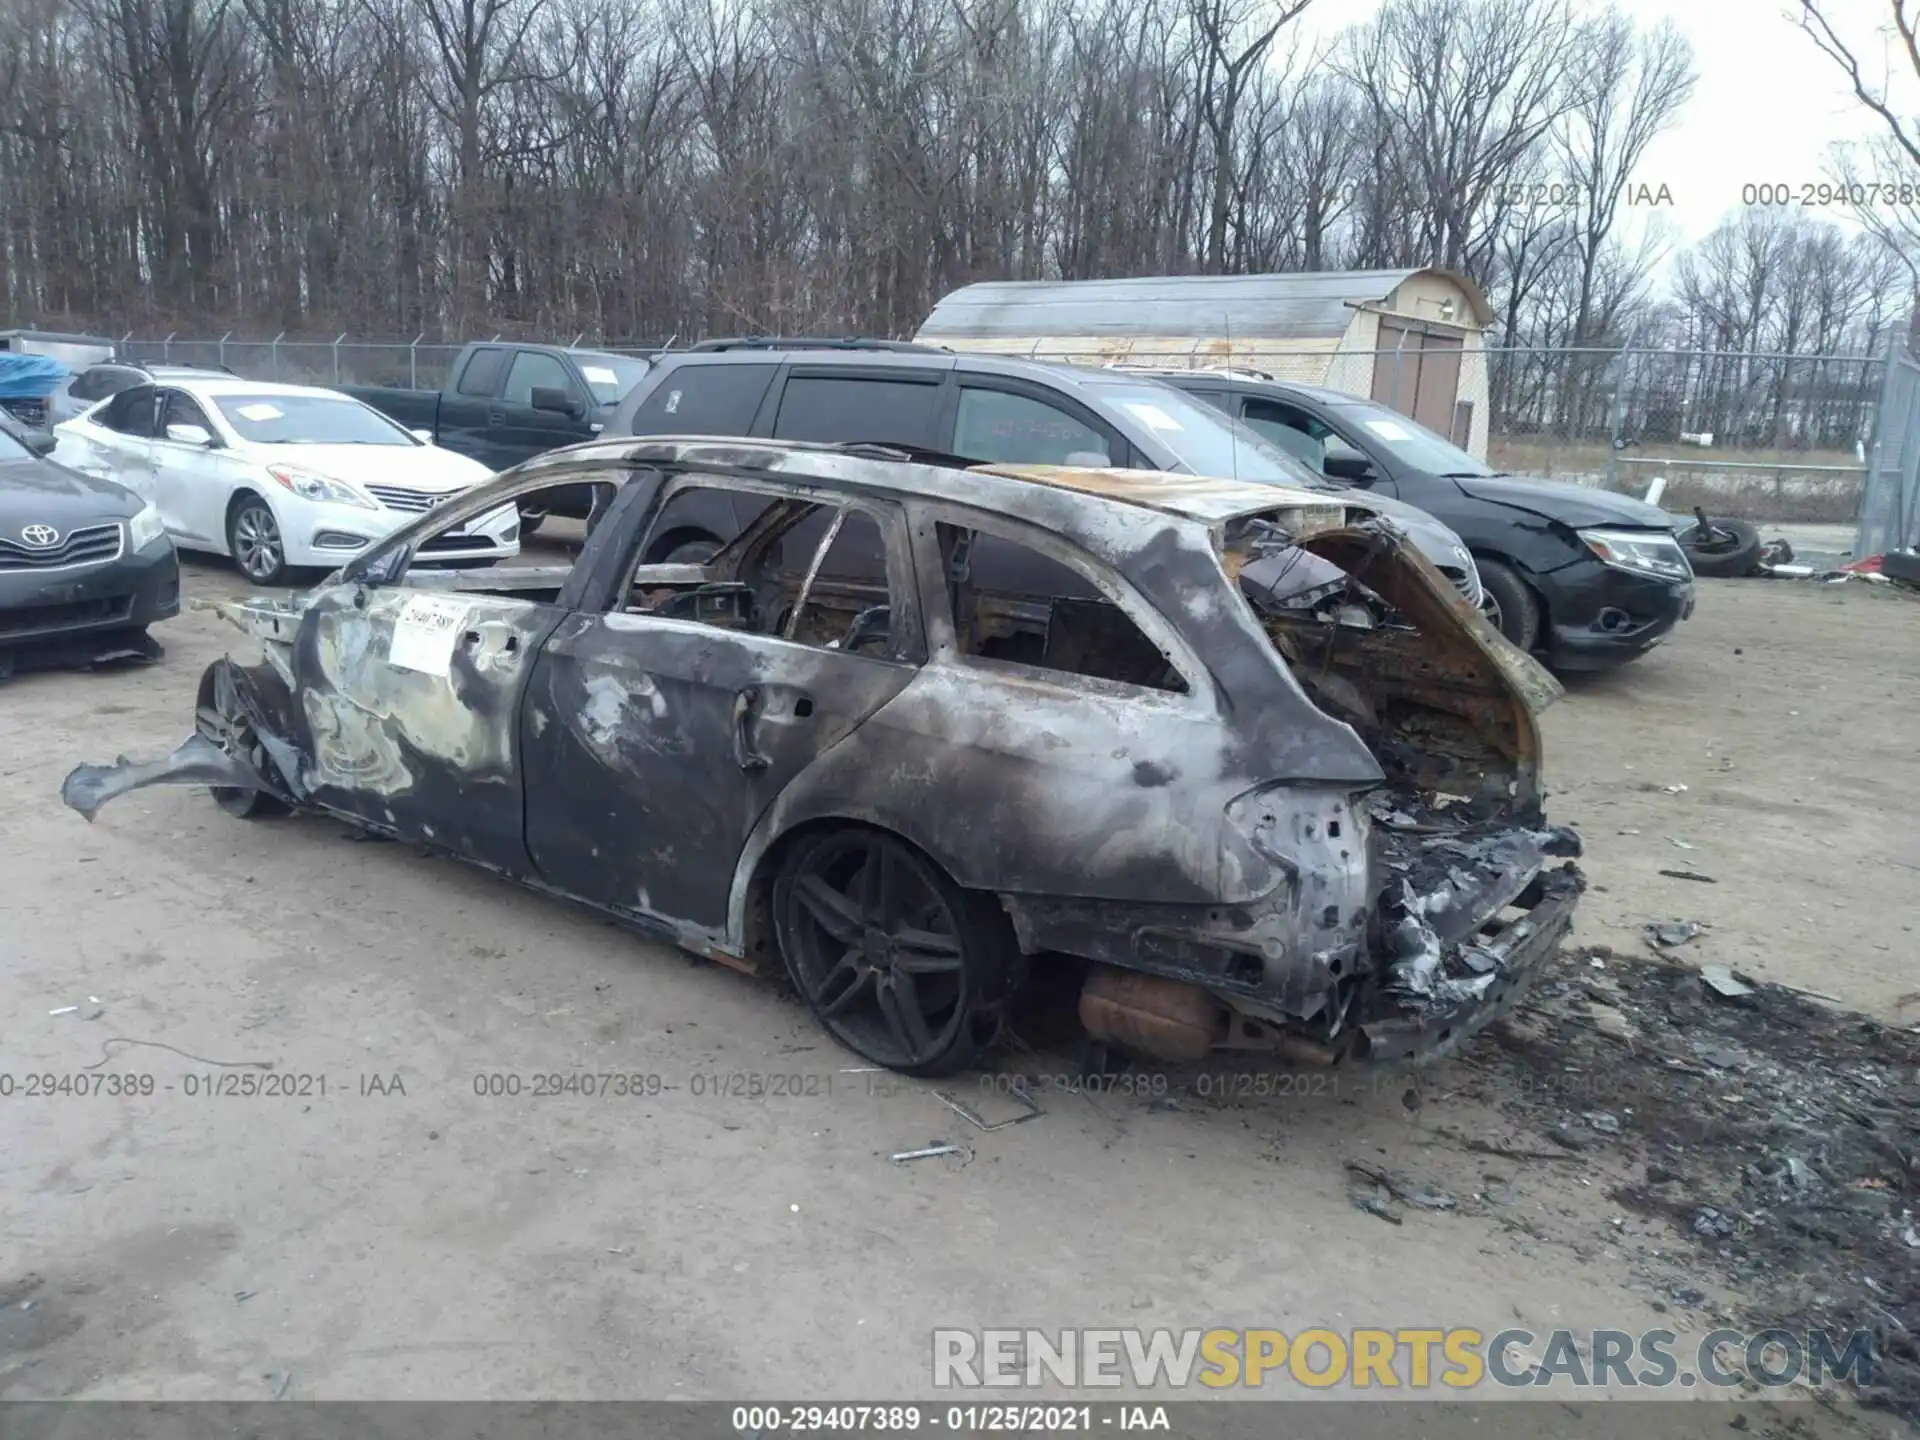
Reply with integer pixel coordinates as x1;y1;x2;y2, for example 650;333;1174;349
914;267;1494;457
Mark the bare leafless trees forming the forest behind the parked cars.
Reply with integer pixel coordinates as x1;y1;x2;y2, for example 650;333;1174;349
0;0;1907;378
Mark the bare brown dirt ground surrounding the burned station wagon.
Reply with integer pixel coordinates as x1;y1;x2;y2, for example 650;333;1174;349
0;545;1920;1434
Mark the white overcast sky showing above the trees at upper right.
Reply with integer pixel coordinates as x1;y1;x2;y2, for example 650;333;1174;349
1300;0;1896;255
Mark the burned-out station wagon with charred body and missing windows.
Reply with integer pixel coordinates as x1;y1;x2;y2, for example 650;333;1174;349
63;440;1582;1073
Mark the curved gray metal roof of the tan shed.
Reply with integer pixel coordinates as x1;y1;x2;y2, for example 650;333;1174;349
918;267;1494;342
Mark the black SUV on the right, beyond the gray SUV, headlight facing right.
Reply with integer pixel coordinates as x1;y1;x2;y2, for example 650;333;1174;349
1140;371;1693;670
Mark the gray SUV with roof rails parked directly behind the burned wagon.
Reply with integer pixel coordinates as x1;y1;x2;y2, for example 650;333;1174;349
607;340;1480;605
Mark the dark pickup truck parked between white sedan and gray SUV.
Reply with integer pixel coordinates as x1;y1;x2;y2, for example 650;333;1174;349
338;340;649;534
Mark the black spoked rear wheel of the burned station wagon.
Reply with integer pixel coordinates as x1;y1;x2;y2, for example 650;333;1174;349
774;826;1021;1075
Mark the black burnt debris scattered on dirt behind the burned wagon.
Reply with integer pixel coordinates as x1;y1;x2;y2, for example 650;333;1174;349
1475;948;1920;1417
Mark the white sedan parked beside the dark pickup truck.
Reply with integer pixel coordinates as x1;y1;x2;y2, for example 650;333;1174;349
54;376;520;586
